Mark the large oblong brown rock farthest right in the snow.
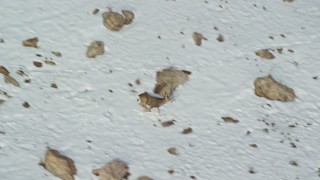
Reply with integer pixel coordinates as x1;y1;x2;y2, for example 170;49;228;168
254;75;296;102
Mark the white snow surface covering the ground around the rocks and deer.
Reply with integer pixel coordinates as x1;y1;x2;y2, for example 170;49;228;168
0;0;320;180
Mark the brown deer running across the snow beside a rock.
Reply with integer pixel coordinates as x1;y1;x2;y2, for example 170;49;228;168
139;92;170;113
